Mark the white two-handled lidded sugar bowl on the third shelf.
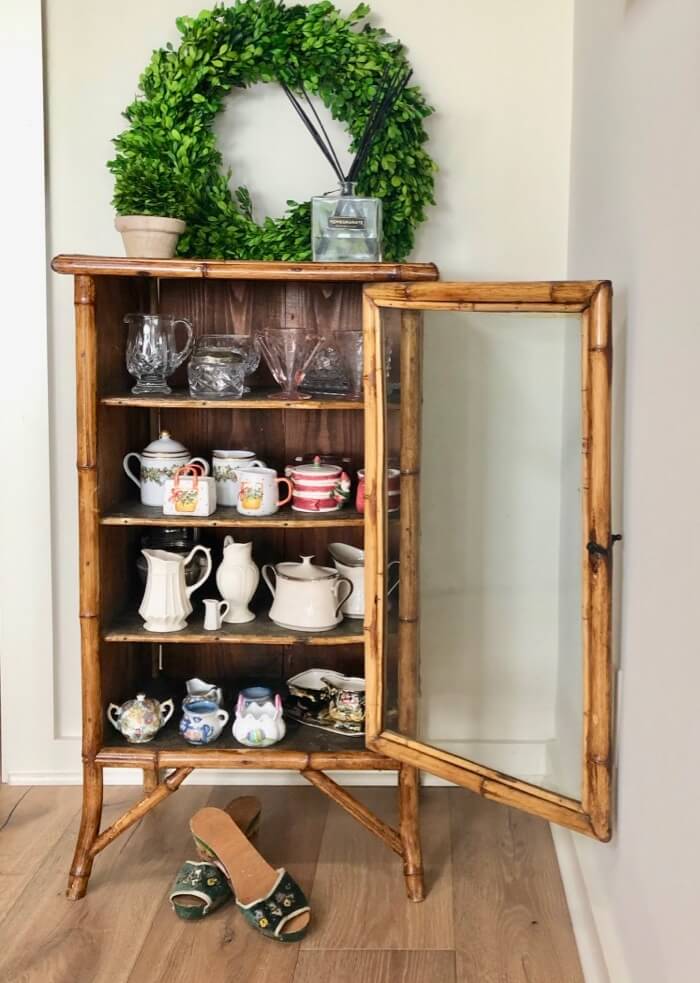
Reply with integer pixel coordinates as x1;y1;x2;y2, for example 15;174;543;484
262;556;353;631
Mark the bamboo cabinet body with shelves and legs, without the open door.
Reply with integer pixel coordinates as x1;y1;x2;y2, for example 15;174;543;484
52;256;438;901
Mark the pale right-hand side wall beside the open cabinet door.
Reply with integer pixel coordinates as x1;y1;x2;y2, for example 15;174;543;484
569;0;700;983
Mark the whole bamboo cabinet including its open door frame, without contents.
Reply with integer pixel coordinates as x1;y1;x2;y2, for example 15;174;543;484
52;256;611;901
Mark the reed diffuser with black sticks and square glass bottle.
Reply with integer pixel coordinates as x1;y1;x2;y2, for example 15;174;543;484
283;66;412;263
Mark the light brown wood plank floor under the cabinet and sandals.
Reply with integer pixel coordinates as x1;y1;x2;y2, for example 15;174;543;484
0;786;583;983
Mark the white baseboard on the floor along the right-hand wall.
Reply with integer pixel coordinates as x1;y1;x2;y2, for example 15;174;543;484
551;824;618;983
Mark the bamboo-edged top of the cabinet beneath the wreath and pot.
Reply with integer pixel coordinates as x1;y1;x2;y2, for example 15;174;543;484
51;255;440;283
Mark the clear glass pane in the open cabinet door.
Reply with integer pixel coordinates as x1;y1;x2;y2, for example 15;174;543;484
381;309;585;799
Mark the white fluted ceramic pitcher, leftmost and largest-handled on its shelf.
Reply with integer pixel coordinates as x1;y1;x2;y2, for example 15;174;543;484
139;544;211;632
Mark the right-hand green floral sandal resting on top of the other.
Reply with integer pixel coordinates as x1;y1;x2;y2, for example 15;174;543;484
190;808;311;942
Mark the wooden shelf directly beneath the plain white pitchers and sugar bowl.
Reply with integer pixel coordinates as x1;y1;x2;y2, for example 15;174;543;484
103;612;364;646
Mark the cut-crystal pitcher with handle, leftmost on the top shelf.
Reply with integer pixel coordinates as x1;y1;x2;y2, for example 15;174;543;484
124;314;193;395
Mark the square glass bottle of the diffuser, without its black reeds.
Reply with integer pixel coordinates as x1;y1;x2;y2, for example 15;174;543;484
311;181;382;263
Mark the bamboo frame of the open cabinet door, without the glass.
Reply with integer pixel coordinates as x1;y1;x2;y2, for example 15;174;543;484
363;280;613;841
